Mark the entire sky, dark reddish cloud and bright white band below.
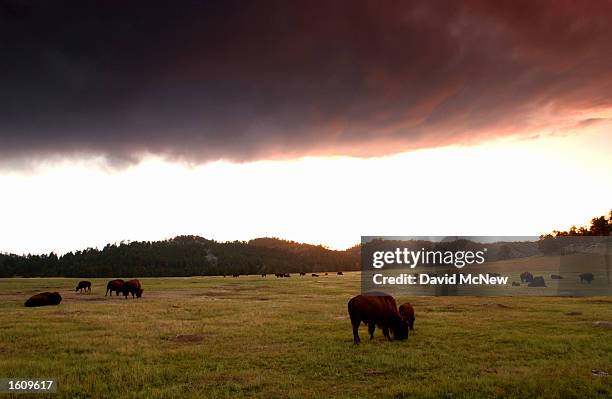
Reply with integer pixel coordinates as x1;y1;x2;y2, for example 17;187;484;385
0;0;612;253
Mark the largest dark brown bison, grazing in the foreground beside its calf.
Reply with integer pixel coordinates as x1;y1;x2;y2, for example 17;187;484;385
348;293;408;344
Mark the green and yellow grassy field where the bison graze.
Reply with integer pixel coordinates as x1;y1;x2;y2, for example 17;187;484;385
0;273;612;399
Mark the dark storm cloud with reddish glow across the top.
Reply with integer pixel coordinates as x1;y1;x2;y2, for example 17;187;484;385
0;0;612;166
